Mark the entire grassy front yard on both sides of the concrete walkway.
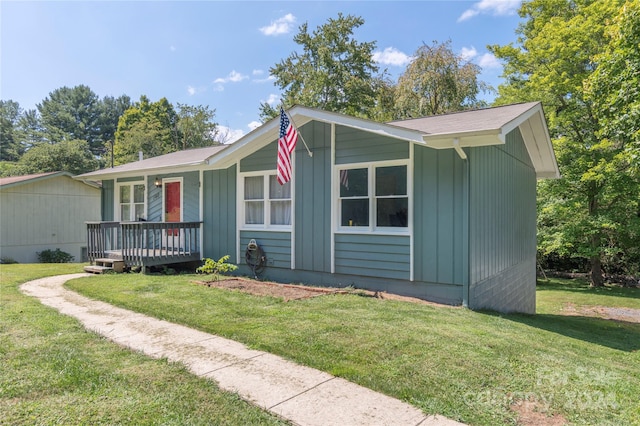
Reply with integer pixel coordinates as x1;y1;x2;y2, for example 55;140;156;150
0;265;640;425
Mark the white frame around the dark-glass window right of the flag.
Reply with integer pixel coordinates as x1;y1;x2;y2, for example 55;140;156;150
334;160;413;235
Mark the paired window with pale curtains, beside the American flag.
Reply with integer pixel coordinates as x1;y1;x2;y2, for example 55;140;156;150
244;174;291;228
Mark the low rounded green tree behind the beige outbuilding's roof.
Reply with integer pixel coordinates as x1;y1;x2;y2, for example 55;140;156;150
17;139;99;175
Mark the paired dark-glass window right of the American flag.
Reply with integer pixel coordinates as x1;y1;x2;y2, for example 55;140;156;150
339;164;409;230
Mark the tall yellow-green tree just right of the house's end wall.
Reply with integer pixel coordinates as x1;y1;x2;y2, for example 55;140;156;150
491;0;638;286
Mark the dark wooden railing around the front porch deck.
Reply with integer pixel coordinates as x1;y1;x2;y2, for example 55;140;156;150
87;222;202;267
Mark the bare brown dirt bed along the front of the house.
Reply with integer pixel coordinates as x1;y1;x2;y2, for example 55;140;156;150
196;277;453;307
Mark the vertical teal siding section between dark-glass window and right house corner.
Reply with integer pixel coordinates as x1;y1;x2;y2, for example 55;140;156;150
413;147;467;285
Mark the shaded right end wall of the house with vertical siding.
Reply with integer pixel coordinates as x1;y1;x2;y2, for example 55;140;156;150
469;129;536;313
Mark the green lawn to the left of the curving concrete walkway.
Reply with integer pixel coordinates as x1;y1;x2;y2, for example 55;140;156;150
0;264;283;425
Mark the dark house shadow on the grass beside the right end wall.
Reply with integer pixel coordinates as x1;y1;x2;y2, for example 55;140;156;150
483;312;640;352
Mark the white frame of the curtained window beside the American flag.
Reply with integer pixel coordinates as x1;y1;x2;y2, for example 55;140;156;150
238;171;294;231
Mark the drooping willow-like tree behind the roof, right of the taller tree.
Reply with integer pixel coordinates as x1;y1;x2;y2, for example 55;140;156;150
395;41;488;118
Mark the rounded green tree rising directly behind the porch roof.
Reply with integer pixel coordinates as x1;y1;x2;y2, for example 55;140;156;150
114;96;180;164
